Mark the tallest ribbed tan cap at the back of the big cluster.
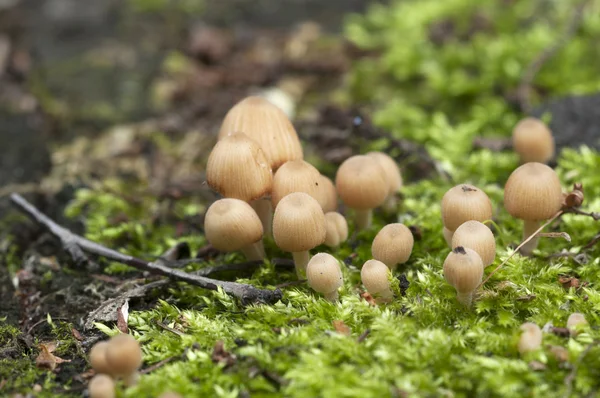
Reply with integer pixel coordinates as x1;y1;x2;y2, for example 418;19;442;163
219;97;303;170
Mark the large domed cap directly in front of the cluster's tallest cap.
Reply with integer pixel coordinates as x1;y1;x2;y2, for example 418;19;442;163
206;133;273;202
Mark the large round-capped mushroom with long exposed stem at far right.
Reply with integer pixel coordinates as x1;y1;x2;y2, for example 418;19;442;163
504;163;563;255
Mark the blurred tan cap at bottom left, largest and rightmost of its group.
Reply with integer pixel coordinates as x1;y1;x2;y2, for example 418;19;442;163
106;334;142;376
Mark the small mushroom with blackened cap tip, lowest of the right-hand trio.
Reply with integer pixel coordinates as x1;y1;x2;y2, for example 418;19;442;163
444;246;483;307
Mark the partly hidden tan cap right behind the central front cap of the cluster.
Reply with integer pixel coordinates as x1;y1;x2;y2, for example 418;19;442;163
271;160;325;208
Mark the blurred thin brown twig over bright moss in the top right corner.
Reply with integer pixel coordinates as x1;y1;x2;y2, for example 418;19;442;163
517;0;588;113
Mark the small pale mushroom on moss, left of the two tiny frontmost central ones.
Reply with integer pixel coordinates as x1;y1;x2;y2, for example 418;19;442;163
306;253;344;301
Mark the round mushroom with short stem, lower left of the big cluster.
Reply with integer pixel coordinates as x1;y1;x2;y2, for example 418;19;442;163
204;198;265;260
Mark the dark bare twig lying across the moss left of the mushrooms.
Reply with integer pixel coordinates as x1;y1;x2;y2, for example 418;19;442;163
10;194;281;304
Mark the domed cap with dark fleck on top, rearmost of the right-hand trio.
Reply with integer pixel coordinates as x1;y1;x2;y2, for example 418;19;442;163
442;184;492;231
